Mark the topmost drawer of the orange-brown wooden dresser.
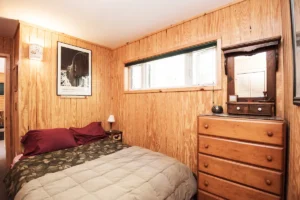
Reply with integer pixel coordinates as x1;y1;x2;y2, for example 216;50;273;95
198;117;285;145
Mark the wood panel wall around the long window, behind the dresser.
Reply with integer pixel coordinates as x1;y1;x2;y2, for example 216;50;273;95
111;0;284;172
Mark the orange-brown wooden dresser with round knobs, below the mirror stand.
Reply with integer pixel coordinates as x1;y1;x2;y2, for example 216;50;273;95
198;115;286;200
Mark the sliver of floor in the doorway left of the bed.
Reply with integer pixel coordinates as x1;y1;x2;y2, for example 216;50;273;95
0;140;8;200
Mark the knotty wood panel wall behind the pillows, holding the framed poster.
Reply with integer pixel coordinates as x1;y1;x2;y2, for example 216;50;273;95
17;22;112;152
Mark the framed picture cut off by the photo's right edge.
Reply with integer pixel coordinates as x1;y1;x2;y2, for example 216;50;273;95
290;0;300;106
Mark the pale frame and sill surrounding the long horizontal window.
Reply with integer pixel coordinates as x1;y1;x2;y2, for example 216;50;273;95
124;39;222;94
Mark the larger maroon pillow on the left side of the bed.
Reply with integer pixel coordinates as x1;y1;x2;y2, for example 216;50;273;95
21;128;77;156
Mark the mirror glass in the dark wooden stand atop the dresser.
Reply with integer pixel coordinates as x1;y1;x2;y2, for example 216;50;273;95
234;52;267;98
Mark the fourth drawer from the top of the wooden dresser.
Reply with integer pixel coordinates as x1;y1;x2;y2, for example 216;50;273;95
198;172;280;200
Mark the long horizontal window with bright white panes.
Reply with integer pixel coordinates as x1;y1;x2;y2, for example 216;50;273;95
126;42;219;91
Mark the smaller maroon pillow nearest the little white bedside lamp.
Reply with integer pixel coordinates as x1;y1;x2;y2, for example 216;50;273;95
70;122;107;145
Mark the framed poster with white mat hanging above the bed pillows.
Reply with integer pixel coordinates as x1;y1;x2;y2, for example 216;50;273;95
57;42;92;96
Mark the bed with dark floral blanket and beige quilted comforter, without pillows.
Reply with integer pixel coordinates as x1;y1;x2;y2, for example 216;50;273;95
4;138;197;200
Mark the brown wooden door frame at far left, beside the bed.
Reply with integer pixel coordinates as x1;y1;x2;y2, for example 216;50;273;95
0;53;13;166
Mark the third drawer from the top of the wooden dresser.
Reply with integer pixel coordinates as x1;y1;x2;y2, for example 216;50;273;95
198;154;282;195
